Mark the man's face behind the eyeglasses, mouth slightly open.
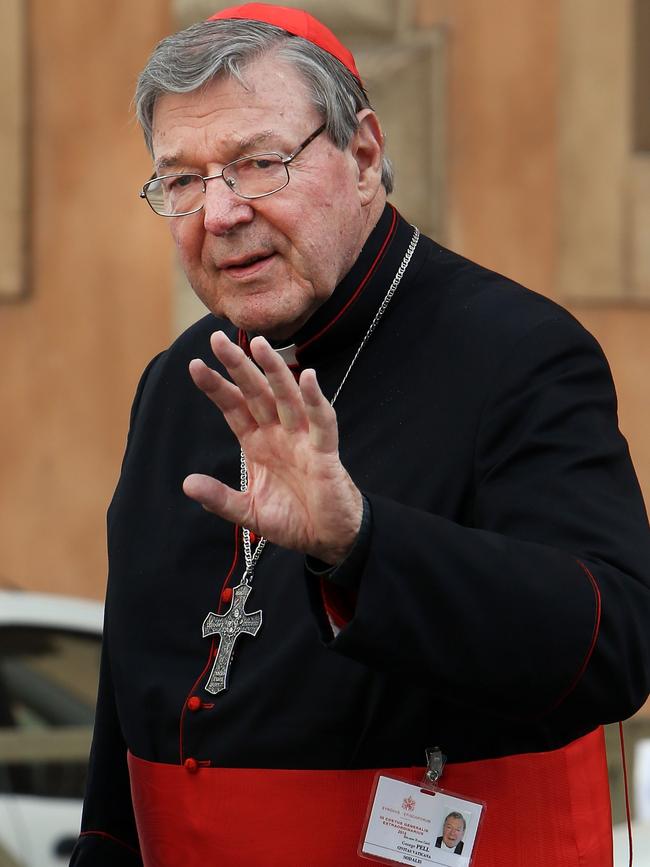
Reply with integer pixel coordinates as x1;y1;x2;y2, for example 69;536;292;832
153;56;383;339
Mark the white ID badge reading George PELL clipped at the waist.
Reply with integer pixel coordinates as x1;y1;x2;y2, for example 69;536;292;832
358;751;485;867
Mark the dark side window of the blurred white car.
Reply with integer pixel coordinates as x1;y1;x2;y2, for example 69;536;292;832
0;626;100;798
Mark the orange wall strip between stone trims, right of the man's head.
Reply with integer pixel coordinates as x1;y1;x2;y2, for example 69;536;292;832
418;0;557;294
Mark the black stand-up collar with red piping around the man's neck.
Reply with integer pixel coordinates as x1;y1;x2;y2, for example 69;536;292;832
240;204;413;367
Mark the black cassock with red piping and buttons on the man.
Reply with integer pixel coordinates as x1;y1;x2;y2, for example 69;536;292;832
73;206;650;867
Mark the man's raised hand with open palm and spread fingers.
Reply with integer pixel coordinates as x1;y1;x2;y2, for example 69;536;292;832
183;331;363;564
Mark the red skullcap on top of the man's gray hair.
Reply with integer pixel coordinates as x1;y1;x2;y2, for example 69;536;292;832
208;3;361;82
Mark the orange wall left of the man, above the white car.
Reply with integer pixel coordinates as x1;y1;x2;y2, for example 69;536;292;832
0;0;170;597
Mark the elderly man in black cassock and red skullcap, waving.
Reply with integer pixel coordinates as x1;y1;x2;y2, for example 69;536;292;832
72;4;650;867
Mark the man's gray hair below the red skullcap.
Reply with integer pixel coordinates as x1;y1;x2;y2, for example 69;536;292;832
134;19;393;193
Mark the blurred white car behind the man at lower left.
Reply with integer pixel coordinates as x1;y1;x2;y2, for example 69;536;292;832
0;591;103;867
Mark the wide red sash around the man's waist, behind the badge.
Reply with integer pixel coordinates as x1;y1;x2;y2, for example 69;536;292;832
129;729;612;867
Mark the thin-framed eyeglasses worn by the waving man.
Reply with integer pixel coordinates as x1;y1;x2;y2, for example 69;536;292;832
140;124;325;217
